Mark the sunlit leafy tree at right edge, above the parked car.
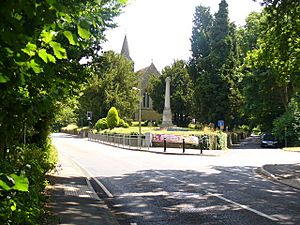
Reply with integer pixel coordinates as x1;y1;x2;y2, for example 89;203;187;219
243;1;300;130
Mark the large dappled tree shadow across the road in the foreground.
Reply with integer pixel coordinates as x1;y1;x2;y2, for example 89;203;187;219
98;166;300;225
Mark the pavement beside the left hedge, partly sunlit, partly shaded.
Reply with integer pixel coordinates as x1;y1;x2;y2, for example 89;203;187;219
47;152;119;225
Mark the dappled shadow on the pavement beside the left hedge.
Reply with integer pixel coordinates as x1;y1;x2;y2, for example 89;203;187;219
43;175;115;225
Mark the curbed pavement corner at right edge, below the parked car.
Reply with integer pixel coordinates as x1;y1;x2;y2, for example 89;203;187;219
257;163;300;189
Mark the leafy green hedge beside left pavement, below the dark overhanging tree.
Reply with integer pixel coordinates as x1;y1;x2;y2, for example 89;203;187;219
0;143;57;225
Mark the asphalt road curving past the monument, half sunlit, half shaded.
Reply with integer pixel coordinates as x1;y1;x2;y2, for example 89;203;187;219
53;134;300;225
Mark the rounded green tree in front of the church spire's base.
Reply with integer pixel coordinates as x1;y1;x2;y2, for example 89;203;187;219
78;51;138;123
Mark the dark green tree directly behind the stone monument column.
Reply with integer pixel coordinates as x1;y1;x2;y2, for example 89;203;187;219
149;60;193;126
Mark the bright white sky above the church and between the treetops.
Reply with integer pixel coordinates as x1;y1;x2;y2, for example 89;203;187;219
103;0;261;71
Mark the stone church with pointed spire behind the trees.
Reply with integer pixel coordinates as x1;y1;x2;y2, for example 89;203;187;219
121;35;162;121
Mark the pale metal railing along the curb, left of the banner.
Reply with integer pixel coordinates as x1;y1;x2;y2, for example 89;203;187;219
88;133;151;149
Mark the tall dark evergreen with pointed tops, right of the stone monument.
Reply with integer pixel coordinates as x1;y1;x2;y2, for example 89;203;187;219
190;0;240;125
